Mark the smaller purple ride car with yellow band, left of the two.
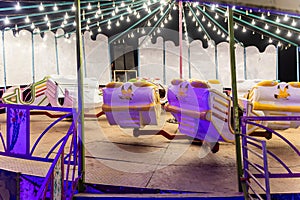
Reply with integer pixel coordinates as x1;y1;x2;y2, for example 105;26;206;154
102;81;161;128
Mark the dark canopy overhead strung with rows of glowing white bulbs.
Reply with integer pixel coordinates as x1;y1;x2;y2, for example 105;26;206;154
0;0;300;51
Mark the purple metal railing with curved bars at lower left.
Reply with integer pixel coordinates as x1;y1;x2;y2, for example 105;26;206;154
0;104;78;199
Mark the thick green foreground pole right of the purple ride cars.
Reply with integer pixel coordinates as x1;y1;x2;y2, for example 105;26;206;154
228;7;243;192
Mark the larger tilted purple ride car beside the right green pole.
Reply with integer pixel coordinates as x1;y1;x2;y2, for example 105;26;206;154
165;79;234;142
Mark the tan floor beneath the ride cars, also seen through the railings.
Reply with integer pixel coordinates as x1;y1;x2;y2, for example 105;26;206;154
0;113;300;196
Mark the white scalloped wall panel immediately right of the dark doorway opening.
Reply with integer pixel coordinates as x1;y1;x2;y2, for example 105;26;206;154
138;37;165;81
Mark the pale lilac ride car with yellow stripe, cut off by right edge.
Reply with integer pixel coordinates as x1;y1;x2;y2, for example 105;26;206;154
241;81;300;130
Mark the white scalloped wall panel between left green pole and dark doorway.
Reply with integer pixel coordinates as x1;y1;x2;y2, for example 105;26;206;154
84;32;110;84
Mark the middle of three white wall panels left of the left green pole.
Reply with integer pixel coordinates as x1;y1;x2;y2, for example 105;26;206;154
33;31;57;81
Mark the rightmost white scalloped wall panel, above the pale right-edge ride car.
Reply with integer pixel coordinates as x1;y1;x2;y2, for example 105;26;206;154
246;46;276;80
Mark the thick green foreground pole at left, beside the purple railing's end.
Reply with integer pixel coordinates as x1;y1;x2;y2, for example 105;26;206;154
75;0;85;192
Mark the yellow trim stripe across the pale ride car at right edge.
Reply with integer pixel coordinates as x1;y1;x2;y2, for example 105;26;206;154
253;102;300;112
